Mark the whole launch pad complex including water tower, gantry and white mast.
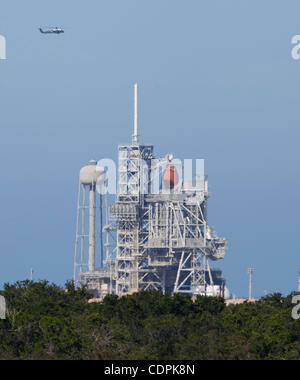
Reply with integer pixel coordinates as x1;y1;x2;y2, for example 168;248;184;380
74;85;226;298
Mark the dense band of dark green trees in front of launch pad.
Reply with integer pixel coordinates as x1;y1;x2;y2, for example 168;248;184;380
0;281;300;360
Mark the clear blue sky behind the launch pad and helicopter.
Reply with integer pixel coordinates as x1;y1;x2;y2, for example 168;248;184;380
0;0;300;296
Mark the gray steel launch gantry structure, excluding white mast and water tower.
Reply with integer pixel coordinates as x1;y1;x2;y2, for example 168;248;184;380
110;142;226;296
